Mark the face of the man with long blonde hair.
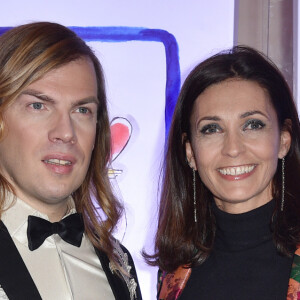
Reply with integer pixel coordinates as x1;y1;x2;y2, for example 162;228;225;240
0;59;98;212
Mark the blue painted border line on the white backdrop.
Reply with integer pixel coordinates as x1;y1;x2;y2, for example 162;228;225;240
0;26;180;137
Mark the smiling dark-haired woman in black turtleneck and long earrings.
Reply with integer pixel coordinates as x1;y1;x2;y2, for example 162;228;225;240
152;46;300;300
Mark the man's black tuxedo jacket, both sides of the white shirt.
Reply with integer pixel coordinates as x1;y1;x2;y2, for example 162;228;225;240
0;221;142;300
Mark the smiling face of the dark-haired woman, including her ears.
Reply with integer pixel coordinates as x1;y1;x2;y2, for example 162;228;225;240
186;79;291;213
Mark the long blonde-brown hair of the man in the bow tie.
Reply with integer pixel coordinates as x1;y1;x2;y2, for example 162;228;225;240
0;22;123;266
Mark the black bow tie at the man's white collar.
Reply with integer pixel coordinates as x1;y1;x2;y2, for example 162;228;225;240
27;213;84;251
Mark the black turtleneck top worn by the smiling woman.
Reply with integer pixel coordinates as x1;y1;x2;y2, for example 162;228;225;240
179;201;292;300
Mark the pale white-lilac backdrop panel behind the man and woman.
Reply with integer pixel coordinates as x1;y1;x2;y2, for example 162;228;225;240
0;0;234;300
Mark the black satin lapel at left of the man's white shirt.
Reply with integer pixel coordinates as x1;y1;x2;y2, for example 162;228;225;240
0;221;42;300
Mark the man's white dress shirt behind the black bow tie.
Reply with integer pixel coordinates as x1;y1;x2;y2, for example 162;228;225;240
0;194;115;300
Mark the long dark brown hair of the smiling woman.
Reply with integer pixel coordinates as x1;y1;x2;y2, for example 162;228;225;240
146;46;300;271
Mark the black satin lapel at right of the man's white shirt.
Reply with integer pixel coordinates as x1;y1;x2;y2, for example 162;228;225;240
95;248;130;300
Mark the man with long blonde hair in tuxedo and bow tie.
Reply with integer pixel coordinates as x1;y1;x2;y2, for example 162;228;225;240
0;22;141;300
